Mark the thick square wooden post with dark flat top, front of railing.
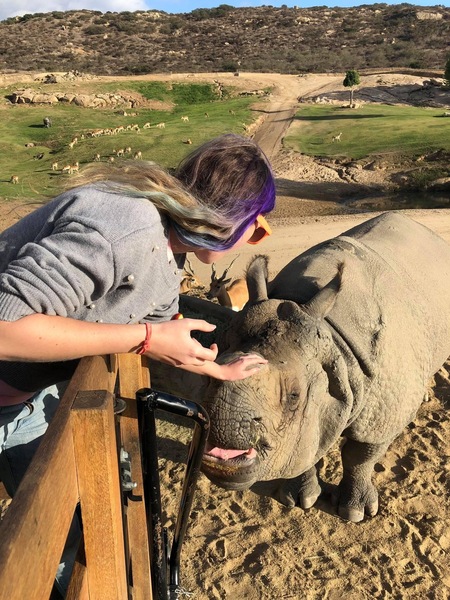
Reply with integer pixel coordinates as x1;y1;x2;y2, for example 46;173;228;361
71;390;128;600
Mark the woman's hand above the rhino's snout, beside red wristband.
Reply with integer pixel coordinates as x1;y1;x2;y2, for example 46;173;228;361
146;319;218;368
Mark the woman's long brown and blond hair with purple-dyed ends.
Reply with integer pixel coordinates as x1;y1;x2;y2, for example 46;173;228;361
71;134;275;250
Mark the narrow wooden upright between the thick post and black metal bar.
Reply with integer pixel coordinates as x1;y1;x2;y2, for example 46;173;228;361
118;354;153;600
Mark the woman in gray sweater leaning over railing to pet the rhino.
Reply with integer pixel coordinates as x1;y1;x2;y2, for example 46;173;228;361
0;134;275;589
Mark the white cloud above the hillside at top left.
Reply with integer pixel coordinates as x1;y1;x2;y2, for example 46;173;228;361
0;0;148;21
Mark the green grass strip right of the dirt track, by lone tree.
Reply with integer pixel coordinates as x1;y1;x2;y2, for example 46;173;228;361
284;104;450;160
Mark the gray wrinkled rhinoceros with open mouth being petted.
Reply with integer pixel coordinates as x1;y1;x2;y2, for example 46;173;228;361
203;213;450;522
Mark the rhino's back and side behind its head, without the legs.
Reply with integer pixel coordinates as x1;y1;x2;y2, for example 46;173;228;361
269;213;450;437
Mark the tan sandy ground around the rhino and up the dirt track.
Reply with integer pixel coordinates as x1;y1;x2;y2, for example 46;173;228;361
0;74;450;600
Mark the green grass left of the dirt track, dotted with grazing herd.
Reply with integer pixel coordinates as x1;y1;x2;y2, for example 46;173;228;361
0;82;257;201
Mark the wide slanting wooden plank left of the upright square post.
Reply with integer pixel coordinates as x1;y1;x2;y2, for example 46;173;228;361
0;394;78;600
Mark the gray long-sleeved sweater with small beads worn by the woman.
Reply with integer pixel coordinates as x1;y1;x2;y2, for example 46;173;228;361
0;185;185;391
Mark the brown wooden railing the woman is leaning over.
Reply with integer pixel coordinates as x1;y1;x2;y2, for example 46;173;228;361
0;355;152;600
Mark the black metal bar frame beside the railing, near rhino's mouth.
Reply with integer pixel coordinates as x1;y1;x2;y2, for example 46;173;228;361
136;389;209;599
